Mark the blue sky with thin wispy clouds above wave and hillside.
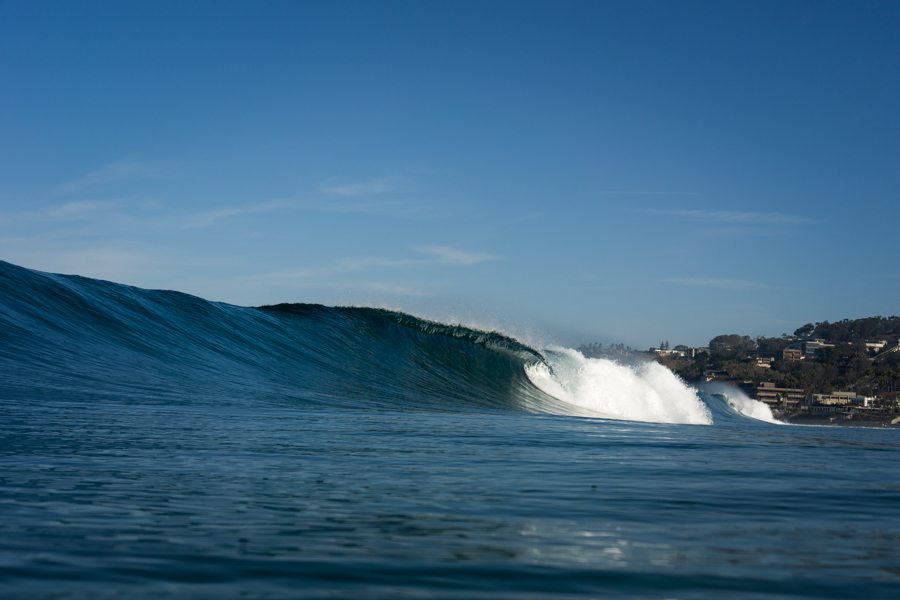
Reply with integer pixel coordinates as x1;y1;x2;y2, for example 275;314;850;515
0;1;900;349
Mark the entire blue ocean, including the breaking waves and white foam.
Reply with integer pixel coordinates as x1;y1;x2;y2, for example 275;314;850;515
0;262;900;599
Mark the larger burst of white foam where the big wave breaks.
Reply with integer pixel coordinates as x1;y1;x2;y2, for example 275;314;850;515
526;347;712;425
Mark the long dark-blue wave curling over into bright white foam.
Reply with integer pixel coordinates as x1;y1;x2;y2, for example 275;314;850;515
0;261;771;424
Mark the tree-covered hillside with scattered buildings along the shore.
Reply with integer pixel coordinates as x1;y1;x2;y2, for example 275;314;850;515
578;315;900;428
